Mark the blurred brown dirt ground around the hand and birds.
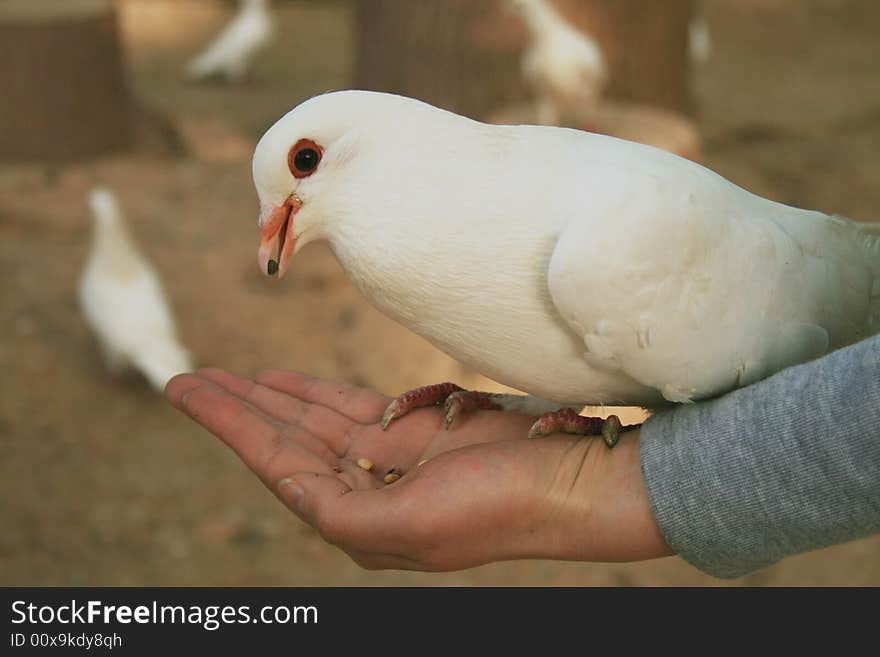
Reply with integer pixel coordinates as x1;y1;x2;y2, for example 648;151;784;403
0;0;880;586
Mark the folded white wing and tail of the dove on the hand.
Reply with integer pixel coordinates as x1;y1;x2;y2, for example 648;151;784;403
548;145;880;402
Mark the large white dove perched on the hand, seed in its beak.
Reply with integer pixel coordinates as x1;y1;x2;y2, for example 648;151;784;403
253;91;880;444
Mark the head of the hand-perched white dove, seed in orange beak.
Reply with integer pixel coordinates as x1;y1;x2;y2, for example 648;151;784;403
253;91;468;278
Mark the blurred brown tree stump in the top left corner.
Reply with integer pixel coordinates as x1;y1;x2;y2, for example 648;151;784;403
0;0;134;163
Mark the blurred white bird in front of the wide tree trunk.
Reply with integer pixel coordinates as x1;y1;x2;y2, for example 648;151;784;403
508;0;608;125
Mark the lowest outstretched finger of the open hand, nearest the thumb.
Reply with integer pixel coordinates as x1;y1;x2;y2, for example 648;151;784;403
175;376;337;485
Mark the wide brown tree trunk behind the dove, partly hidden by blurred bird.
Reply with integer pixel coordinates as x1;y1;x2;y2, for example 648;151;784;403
355;0;692;118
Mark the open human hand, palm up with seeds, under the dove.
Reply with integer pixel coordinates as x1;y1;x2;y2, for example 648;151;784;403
165;369;671;570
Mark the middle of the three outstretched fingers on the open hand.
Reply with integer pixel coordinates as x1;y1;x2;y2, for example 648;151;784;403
199;369;354;456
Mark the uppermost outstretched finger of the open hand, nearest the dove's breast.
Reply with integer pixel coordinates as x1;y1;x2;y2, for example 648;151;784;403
256;370;388;424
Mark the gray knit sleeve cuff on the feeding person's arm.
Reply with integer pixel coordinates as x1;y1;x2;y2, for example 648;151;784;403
641;336;880;577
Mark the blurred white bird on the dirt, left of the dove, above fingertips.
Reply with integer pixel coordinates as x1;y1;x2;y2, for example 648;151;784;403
79;188;193;392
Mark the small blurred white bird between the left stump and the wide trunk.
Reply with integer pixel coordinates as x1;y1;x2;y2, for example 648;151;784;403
186;0;273;81
